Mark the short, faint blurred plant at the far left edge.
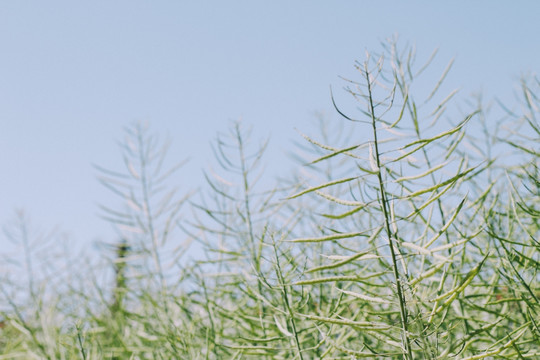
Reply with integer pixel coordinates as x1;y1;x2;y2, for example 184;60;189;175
0;210;65;359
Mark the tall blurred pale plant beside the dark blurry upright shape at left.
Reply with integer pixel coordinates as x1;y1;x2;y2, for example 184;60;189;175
91;123;194;356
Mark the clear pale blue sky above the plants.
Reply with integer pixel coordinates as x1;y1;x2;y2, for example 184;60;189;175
0;0;540;258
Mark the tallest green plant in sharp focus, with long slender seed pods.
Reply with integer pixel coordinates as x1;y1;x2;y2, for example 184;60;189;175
280;42;538;359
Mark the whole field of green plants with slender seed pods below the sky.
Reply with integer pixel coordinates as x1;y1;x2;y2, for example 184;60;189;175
0;42;540;360
